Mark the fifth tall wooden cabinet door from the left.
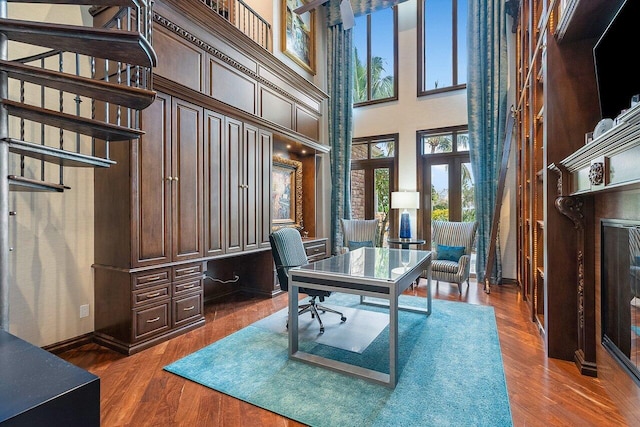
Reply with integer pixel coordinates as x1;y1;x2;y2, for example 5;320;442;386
243;124;262;250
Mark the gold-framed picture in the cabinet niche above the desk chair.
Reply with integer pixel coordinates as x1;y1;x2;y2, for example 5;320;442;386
271;156;302;229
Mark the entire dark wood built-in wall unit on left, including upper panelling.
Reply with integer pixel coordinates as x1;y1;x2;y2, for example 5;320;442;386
92;0;329;354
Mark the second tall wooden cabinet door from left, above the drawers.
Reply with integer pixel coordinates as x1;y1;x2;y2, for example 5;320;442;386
170;99;203;261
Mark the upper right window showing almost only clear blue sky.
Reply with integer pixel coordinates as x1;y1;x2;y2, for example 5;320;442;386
418;0;467;96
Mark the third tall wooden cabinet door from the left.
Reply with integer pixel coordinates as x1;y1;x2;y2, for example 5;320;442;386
204;111;227;256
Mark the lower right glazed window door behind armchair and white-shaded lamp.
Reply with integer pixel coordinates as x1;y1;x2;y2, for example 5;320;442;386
417;126;476;271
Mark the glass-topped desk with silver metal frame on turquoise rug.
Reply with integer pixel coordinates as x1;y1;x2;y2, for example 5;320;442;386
288;248;431;388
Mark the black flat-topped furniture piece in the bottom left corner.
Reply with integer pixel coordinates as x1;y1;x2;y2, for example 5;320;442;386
0;330;100;427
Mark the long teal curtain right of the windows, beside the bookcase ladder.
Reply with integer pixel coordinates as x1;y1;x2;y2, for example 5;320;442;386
467;0;509;283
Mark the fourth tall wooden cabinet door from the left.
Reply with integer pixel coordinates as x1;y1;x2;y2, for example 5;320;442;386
225;117;244;253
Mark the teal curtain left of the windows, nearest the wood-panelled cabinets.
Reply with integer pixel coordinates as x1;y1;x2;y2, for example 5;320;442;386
325;0;406;254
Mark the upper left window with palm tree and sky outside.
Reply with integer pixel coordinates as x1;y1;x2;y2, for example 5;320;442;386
352;7;398;107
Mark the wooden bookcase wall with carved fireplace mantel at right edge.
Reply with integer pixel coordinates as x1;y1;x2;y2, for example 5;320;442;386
516;0;640;425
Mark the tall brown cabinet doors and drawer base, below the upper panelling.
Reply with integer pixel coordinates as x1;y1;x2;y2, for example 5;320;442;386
94;92;273;354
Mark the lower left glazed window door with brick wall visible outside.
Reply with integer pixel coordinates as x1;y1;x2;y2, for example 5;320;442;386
351;135;398;246
